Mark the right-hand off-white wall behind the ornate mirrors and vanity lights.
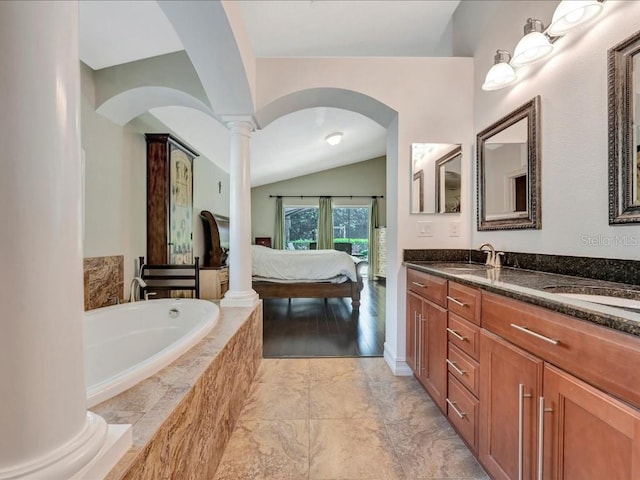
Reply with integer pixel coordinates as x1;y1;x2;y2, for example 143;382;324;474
454;0;640;259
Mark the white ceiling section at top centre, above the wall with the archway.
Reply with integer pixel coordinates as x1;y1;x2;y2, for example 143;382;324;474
240;0;460;57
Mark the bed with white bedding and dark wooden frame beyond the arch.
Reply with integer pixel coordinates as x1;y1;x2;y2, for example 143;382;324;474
251;245;368;310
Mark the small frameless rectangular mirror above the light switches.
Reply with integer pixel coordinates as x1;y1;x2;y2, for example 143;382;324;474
411;143;462;214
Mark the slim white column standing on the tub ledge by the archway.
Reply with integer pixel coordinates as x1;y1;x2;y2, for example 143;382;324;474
220;117;259;307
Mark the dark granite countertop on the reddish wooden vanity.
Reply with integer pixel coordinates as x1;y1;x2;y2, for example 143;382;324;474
403;261;640;336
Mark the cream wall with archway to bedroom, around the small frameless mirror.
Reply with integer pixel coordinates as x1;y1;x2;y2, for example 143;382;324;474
256;58;473;369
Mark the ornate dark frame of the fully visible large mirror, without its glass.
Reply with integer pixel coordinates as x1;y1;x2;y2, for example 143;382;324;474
476;96;542;231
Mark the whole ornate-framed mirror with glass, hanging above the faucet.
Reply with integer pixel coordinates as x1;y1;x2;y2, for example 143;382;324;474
477;97;542;230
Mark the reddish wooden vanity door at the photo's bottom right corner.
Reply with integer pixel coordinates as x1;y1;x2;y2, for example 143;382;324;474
543;364;640;480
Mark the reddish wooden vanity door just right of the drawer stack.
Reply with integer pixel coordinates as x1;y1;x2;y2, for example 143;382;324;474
479;330;544;480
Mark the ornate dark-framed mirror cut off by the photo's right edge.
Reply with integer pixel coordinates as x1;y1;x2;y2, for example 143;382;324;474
608;32;640;225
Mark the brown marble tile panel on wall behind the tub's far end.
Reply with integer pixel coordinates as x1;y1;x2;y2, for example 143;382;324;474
83;255;124;310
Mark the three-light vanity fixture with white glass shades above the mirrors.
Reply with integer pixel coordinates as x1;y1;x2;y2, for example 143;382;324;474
482;0;604;91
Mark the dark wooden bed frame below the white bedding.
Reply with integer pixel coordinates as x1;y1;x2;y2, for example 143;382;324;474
252;262;368;310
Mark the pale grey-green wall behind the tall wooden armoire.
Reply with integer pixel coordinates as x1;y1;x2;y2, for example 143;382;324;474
81;64;229;298
